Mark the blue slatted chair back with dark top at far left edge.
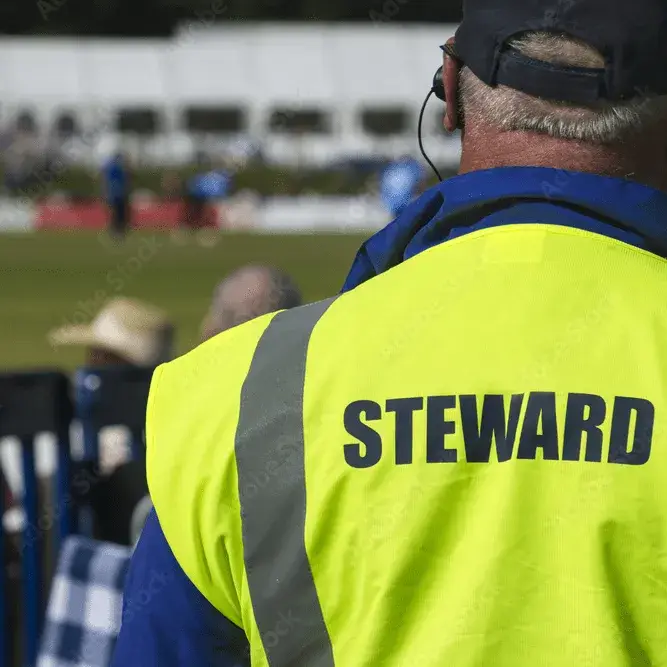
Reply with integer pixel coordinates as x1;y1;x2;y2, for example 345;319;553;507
0;371;73;667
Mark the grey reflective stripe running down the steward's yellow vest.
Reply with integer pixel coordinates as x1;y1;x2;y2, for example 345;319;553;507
235;297;336;667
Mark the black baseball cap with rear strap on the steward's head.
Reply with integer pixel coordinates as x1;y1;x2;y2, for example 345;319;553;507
454;0;667;105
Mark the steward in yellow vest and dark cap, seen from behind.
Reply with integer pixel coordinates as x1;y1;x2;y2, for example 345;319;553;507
112;0;667;667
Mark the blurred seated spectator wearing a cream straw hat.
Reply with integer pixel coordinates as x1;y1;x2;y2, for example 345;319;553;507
49;297;174;544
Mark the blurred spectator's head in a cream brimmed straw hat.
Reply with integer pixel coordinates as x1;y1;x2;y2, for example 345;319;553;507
49;297;174;367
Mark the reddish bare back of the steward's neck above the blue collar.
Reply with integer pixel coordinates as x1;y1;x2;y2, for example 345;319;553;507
459;122;667;192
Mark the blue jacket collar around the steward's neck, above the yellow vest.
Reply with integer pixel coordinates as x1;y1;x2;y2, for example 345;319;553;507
343;167;667;292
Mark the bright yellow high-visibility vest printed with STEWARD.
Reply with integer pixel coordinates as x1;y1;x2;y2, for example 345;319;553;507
147;224;667;667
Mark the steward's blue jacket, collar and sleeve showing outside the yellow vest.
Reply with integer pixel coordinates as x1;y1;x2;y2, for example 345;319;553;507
111;167;667;667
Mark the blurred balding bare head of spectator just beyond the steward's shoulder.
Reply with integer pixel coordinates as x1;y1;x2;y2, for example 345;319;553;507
202;265;302;340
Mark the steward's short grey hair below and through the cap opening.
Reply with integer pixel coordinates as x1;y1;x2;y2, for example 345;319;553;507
460;32;667;144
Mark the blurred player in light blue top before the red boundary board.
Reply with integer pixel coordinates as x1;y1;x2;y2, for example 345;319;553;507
174;156;232;246
